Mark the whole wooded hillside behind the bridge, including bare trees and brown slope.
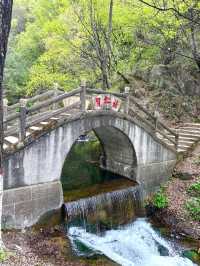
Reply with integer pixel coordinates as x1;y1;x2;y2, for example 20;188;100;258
4;0;200;120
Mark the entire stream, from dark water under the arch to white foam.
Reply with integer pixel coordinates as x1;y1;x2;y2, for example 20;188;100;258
62;136;196;266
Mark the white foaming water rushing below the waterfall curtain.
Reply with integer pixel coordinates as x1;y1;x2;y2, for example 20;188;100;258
69;219;196;266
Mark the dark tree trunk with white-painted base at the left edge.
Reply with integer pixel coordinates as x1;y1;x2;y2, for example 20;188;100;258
0;0;13;246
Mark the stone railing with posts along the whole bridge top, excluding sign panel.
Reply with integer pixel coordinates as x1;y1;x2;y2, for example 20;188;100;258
4;82;178;151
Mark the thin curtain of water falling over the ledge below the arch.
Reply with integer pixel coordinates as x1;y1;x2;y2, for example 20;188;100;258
62;186;141;229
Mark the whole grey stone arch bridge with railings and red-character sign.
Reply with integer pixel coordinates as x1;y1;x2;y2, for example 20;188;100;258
3;83;184;228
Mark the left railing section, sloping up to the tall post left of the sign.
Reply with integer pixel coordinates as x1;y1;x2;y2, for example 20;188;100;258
4;88;82;141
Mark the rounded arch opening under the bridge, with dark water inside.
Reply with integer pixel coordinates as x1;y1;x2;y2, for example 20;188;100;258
61;126;137;203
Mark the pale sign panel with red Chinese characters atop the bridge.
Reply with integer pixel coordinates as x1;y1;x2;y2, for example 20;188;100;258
93;94;121;111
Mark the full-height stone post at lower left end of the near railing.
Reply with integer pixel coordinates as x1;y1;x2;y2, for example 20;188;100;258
19;99;27;142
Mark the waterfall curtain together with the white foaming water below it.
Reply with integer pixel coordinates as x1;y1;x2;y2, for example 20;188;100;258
63;185;196;266
